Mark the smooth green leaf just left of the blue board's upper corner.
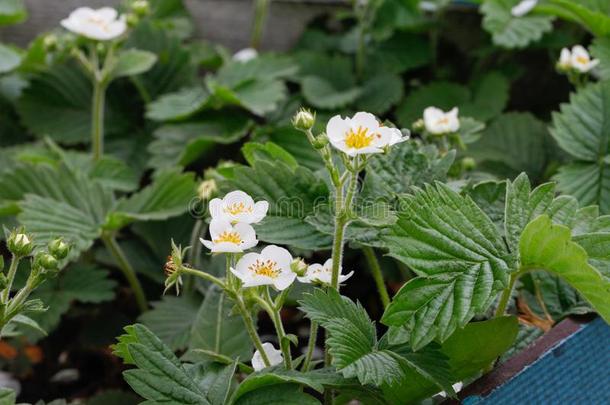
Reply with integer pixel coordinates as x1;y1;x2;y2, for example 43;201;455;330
441;316;519;381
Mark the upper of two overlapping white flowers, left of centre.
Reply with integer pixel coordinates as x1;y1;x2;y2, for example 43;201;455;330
209;190;269;224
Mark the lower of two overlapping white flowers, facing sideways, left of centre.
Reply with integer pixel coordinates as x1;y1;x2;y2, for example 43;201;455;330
199;218;258;253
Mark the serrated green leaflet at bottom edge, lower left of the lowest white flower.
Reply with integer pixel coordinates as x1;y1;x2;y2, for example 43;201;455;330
121;324;209;405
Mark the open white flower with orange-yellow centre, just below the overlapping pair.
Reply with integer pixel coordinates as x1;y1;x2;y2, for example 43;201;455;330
231;245;297;291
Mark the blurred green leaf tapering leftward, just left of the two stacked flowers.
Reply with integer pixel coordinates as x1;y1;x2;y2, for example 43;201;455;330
109;166;196;226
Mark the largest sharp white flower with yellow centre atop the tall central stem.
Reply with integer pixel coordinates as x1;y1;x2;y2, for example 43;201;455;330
326;112;408;156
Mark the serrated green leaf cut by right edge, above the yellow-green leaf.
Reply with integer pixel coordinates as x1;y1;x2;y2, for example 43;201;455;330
551;82;610;213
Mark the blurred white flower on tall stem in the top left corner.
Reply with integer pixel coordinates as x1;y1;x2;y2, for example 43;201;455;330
61;7;127;41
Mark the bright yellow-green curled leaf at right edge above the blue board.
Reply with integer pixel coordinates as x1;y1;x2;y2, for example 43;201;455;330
519;215;610;322
